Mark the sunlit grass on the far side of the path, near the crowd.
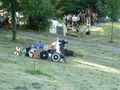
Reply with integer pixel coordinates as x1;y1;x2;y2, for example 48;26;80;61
48;23;120;47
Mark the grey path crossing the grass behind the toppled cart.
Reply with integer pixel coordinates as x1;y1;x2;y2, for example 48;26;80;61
18;31;120;52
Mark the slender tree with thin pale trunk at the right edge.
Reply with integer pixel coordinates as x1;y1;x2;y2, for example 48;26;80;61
98;0;120;42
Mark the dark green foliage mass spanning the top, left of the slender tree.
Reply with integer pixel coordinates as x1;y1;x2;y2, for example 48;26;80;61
0;0;100;30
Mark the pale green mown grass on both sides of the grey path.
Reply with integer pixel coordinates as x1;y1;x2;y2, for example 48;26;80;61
0;24;120;90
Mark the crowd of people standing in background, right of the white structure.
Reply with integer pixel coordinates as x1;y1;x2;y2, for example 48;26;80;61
64;8;98;34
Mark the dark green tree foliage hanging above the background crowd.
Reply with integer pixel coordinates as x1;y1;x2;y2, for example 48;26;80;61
49;0;97;17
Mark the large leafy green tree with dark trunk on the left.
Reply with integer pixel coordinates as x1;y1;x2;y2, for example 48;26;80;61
0;0;52;35
